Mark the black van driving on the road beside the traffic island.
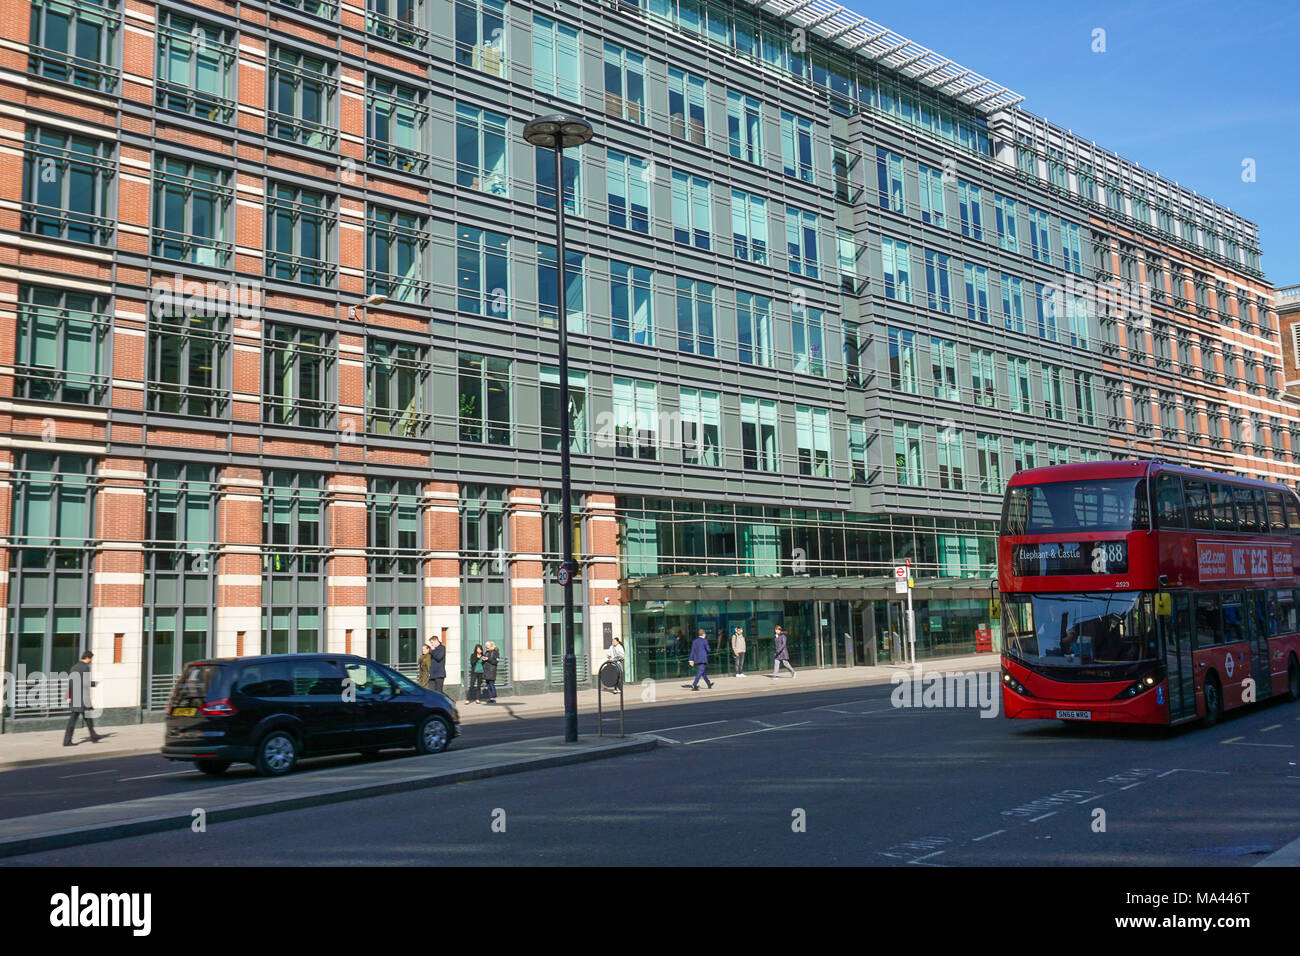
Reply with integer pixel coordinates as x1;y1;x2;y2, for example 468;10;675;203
163;654;460;777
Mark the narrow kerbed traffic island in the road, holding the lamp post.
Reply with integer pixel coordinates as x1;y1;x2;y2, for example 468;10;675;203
0;736;657;857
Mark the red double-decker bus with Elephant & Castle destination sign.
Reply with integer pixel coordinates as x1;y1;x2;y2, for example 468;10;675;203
997;460;1300;723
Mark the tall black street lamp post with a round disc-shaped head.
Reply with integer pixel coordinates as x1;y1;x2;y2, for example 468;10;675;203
524;113;592;744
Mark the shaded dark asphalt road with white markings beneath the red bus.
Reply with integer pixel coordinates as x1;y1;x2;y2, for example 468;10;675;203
4;685;1300;868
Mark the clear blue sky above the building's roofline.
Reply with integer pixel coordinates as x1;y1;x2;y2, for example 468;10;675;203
840;0;1300;285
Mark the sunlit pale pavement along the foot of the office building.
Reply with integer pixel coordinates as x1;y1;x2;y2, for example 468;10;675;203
0;654;998;771
